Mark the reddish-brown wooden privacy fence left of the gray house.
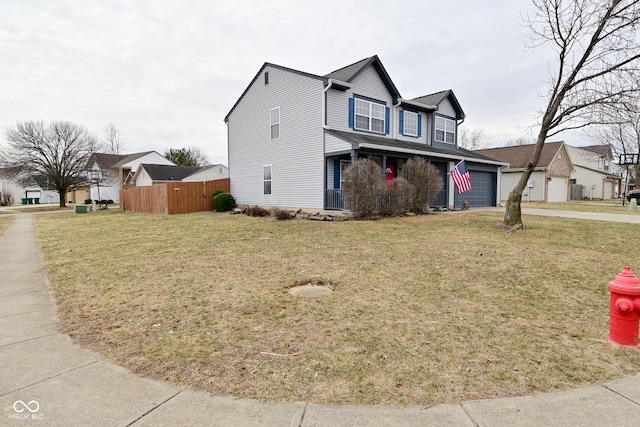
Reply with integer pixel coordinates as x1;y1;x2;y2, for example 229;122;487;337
120;178;230;215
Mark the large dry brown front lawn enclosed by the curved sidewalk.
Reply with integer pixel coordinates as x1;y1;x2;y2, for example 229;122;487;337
36;211;640;405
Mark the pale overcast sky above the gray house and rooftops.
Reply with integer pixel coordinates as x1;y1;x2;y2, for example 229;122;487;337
0;0;588;164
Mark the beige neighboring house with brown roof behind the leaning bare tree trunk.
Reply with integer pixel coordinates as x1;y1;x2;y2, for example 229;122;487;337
476;141;573;202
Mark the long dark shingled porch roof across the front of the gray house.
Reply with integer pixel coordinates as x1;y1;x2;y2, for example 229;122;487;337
326;129;506;166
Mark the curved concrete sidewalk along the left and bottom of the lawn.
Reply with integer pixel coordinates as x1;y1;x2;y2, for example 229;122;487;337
0;213;640;426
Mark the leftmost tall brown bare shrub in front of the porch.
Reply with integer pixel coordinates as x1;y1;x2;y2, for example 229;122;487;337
342;159;384;218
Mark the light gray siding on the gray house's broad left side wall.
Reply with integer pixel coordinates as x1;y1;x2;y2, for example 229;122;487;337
227;66;324;209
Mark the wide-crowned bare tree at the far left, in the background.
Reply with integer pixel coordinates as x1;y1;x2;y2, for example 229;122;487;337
0;121;97;207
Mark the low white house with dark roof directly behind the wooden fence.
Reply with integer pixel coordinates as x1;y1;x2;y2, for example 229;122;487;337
132;163;229;187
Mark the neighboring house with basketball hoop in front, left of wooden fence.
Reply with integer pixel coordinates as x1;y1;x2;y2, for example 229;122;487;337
86;151;175;203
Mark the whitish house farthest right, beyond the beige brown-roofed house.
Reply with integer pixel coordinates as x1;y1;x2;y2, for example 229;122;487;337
567;145;622;200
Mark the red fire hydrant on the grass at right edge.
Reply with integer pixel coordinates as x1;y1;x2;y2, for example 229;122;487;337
608;266;640;347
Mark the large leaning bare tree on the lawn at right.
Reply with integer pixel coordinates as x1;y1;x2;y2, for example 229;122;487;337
504;0;640;229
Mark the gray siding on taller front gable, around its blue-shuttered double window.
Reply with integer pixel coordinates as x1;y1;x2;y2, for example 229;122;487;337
327;65;396;137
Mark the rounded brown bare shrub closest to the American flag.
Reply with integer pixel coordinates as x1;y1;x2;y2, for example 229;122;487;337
400;157;444;213
